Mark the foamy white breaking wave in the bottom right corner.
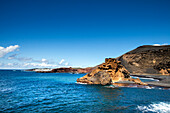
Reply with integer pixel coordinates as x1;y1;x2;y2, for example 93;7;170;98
137;102;170;113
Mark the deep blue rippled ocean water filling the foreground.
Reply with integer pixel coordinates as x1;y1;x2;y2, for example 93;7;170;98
0;70;170;113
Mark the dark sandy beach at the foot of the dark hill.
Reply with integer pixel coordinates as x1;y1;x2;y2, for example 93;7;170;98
131;74;170;88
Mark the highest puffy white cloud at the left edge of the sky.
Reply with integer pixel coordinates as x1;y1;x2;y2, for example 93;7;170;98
0;45;19;58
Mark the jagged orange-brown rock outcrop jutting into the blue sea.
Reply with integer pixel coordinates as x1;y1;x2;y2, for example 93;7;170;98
77;58;146;85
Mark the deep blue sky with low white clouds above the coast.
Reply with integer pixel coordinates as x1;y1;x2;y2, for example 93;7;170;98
0;0;170;69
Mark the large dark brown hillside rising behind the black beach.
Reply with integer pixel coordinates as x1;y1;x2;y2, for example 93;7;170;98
117;45;170;75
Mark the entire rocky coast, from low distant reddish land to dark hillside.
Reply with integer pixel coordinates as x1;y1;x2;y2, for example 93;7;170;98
27;45;170;88
